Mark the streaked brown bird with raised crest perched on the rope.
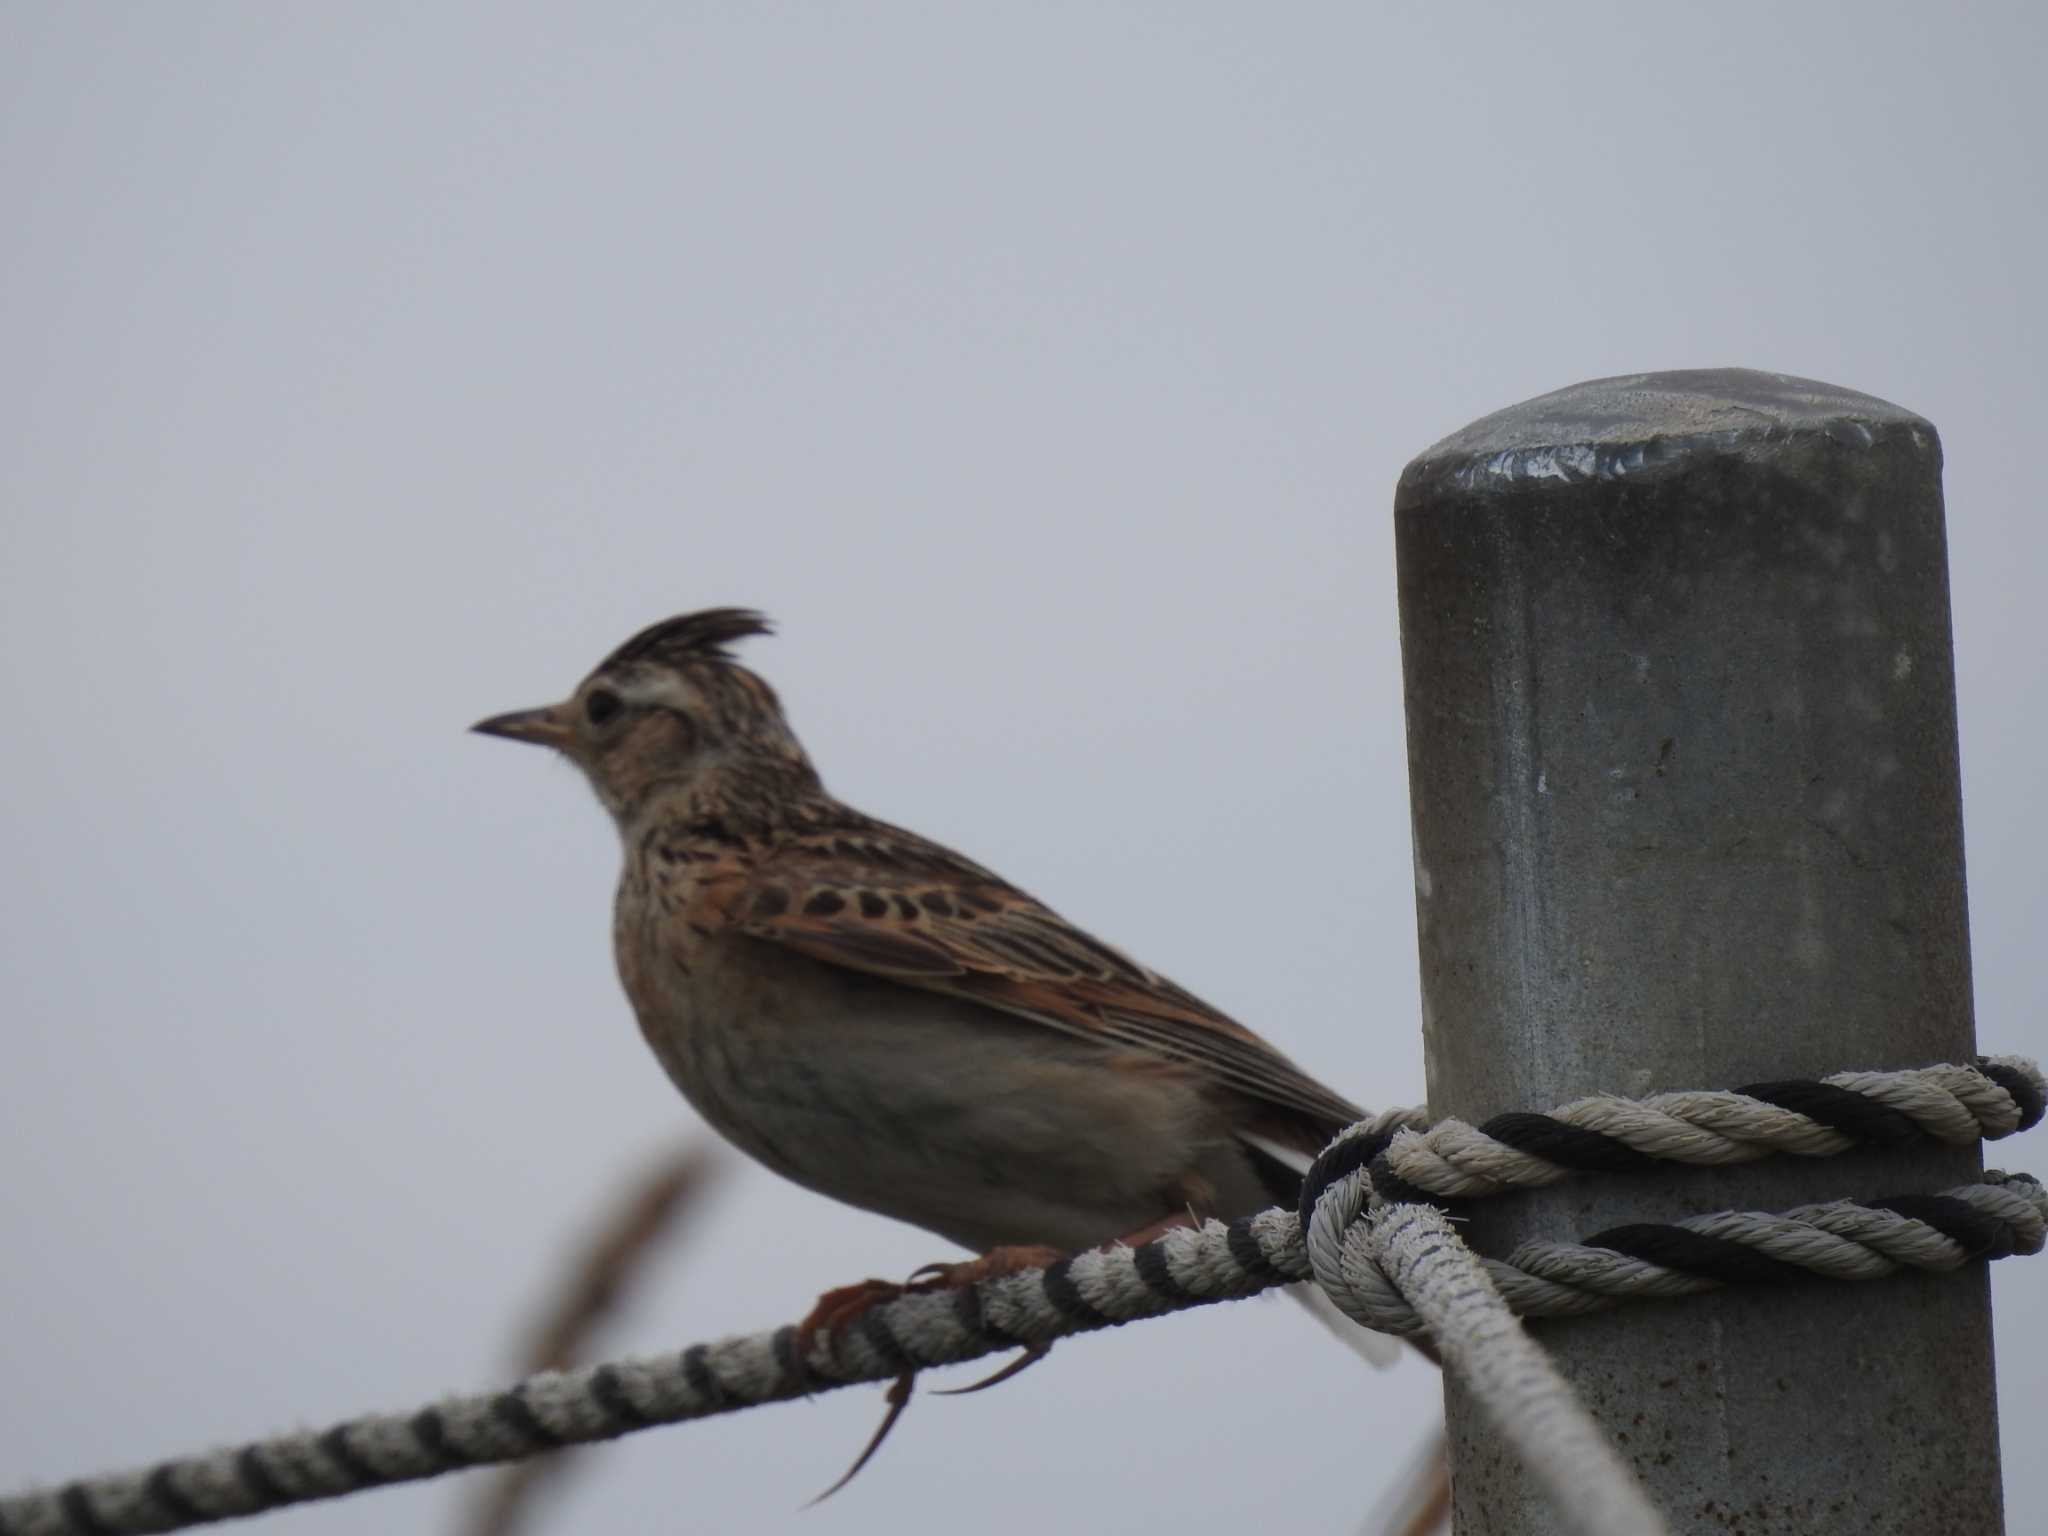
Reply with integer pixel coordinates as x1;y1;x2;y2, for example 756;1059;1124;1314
471;608;1362;1470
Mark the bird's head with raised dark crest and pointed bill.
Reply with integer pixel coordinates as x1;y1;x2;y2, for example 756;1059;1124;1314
469;608;817;827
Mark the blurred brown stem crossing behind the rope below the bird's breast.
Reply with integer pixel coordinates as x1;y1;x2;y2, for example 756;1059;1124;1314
459;1143;721;1536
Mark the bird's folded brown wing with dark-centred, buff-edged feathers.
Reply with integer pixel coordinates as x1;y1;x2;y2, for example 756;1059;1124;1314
707;817;1360;1126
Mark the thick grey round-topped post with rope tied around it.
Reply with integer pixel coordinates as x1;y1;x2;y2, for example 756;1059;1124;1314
1395;371;2003;1536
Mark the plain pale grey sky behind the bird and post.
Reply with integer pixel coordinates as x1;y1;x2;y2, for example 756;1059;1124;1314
0;2;2048;1536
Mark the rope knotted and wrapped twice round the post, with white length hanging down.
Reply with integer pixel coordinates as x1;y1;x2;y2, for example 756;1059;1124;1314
1296;1063;2048;1536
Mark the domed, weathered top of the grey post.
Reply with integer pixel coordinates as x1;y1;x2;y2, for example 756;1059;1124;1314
1395;369;1939;510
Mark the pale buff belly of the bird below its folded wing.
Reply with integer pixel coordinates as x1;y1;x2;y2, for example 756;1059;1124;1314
618;909;1266;1251
